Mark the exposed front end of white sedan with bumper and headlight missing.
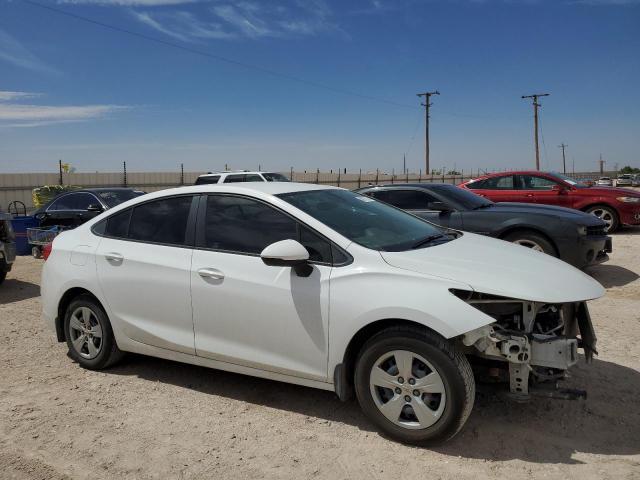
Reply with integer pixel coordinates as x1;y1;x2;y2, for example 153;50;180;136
452;290;597;401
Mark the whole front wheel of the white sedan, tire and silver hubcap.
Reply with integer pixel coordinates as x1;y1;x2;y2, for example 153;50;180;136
355;327;475;445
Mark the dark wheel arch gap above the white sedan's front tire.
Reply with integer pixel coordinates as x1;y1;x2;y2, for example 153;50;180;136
333;318;439;402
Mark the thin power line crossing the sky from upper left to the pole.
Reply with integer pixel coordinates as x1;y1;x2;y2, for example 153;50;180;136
23;0;415;109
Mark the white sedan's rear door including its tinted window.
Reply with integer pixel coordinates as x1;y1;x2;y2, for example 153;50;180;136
94;195;198;354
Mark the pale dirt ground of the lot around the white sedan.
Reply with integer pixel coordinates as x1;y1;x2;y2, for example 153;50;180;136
0;229;640;480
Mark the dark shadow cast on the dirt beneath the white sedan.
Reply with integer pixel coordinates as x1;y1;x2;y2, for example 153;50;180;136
109;355;640;464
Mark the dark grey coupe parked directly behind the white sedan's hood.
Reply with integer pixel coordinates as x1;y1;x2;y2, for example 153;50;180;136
357;183;612;268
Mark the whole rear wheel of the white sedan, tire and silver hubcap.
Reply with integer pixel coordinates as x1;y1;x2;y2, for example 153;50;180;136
64;295;123;370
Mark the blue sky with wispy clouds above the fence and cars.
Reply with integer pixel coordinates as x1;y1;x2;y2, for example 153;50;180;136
0;0;640;172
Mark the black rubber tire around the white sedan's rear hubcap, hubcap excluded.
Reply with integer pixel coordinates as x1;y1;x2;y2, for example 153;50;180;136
64;295;124;370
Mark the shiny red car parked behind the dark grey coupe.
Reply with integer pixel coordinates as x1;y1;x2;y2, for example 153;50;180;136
460;172;640;233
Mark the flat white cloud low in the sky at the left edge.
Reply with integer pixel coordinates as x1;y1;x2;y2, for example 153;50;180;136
0;91;130;128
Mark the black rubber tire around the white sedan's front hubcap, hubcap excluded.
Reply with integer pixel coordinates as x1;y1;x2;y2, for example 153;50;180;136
354;326;475;445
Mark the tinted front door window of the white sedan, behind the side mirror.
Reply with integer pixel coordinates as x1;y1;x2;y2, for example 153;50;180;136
204;195;332;263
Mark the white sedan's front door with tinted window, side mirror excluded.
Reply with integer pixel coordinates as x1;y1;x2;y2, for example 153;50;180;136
191;194;331;380
